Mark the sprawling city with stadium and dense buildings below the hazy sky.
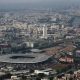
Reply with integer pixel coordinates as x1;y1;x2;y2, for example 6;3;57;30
0;10;80;80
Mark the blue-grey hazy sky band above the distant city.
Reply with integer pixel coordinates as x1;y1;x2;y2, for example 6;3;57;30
0;0;80;9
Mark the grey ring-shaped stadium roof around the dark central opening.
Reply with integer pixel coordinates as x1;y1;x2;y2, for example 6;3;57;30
0;53;51;63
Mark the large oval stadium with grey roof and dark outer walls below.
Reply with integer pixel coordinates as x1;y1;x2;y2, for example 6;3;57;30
0;53;53;69
